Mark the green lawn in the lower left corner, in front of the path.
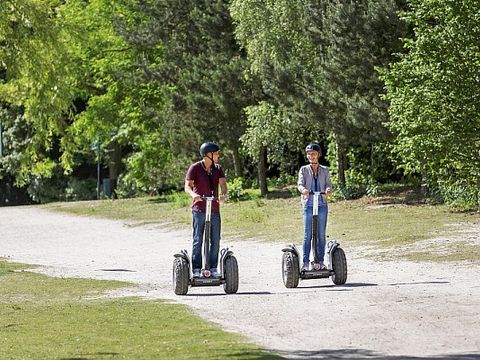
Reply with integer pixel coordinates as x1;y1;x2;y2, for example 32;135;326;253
0;261;279;359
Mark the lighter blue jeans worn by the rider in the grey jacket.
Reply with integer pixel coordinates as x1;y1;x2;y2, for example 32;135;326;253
303;203;328;264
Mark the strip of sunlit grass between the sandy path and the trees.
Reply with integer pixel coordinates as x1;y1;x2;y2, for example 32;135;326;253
47;188;480;261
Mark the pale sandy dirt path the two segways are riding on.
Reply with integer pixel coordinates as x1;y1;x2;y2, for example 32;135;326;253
0;207;480;360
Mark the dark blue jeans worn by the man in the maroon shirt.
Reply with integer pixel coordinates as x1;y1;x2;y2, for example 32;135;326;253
192;211;221;269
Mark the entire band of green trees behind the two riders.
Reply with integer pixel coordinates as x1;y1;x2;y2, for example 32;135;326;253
0;0;480;210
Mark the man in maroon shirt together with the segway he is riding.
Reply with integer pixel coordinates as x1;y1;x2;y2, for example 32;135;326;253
173;142;238;295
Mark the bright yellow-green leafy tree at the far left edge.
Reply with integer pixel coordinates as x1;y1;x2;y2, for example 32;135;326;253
0;0;75;185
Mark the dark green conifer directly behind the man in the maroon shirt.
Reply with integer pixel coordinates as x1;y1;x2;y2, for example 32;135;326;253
117;0;255;180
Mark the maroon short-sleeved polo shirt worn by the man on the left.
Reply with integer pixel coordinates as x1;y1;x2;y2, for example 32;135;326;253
185;161;225;213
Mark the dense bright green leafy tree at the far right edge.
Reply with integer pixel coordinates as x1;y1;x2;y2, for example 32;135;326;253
384;0;480;209
